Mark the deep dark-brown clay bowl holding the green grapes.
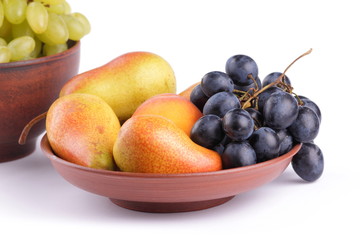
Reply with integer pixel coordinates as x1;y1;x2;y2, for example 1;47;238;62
0;42;80;162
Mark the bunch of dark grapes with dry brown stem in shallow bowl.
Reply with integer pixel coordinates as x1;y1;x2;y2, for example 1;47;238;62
190;50;324;182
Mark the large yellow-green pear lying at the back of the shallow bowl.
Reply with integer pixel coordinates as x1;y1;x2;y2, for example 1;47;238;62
60;52;176;122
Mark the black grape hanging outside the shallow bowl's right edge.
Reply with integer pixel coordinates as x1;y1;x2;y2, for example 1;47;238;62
291;143;324;182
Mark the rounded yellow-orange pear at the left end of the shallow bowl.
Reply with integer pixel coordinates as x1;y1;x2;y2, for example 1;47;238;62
46;93;120;170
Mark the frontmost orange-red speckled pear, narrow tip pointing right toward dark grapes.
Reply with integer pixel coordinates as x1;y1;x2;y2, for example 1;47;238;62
113;115;222;174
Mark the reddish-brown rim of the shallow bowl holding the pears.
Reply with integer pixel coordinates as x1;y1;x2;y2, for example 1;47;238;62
40;134;302;178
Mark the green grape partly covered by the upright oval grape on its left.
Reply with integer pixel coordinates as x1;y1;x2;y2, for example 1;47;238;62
37;13;69;45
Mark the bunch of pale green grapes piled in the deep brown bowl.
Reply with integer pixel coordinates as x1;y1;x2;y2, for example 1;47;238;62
0;0;91;63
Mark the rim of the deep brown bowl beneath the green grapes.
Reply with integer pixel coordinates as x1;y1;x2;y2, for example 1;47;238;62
0;41;80;69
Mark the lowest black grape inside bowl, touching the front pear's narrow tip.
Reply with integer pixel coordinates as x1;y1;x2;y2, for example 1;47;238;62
221;142;256;169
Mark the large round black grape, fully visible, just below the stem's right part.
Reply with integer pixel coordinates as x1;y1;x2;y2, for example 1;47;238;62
263;92;299;129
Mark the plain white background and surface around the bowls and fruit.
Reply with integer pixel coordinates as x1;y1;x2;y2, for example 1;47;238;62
0;0;360;240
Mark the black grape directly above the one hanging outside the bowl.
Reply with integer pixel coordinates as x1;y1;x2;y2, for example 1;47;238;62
288;106;320;143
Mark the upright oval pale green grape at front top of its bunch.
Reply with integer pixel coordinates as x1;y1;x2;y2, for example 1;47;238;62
26;2;49;34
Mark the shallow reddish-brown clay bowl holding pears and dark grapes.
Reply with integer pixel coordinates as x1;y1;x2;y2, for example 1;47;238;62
41;135;301;213
